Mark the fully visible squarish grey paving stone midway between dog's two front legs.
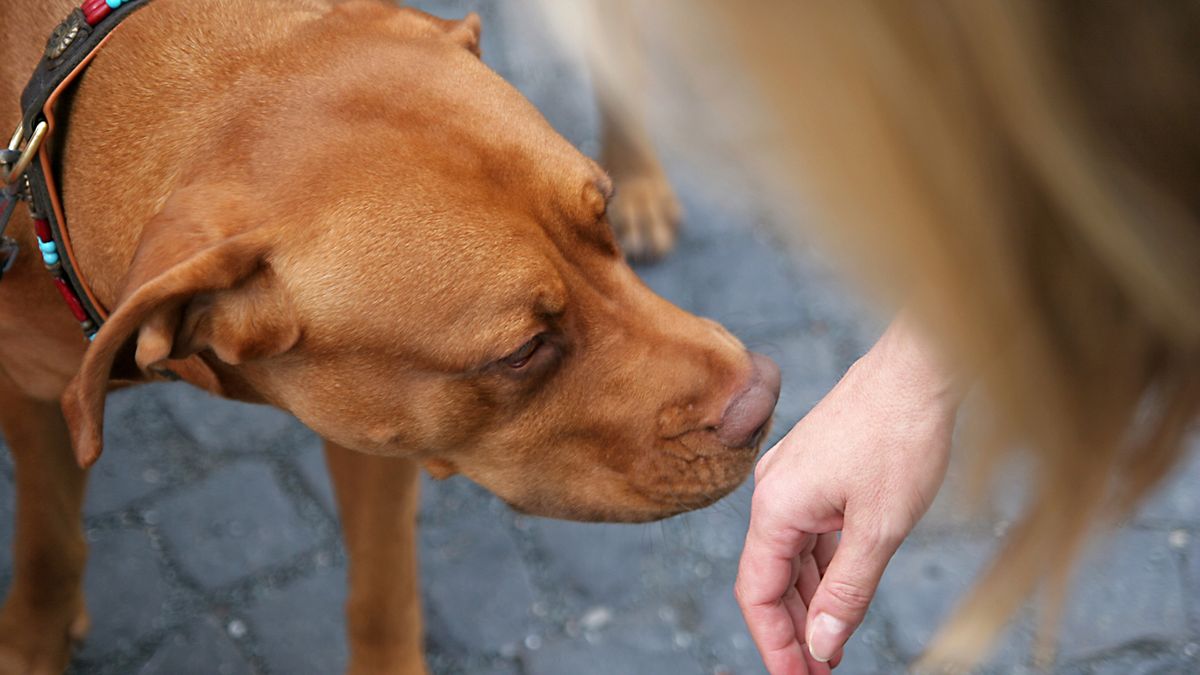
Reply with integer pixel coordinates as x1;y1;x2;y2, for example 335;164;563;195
156;461;318;589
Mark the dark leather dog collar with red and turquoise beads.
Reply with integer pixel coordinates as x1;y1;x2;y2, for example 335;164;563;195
0;0;149;340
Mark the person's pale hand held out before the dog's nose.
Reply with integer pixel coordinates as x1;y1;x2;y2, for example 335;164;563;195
734;321;959;675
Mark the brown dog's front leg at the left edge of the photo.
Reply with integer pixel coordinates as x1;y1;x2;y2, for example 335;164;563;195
0;371;88;675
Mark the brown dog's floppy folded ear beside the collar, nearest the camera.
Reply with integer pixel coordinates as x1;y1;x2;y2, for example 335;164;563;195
62;187;299;467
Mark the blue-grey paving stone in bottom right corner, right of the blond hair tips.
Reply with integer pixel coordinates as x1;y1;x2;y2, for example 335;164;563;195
1061;530;1188;661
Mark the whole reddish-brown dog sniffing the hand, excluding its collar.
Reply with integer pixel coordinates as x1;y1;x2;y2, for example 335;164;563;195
0;0;779;675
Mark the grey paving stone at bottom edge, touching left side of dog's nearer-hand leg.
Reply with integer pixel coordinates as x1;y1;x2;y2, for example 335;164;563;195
246;567;349;675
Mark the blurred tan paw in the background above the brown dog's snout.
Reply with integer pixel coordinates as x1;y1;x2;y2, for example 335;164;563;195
608;167;683;262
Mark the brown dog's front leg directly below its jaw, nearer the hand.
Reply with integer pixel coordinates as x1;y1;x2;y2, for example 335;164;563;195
325;441;426;675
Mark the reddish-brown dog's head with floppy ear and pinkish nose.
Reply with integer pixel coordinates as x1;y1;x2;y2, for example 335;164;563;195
64;8;779;520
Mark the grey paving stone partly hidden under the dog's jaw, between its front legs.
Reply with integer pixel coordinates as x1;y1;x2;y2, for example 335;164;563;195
157;383;312;454
